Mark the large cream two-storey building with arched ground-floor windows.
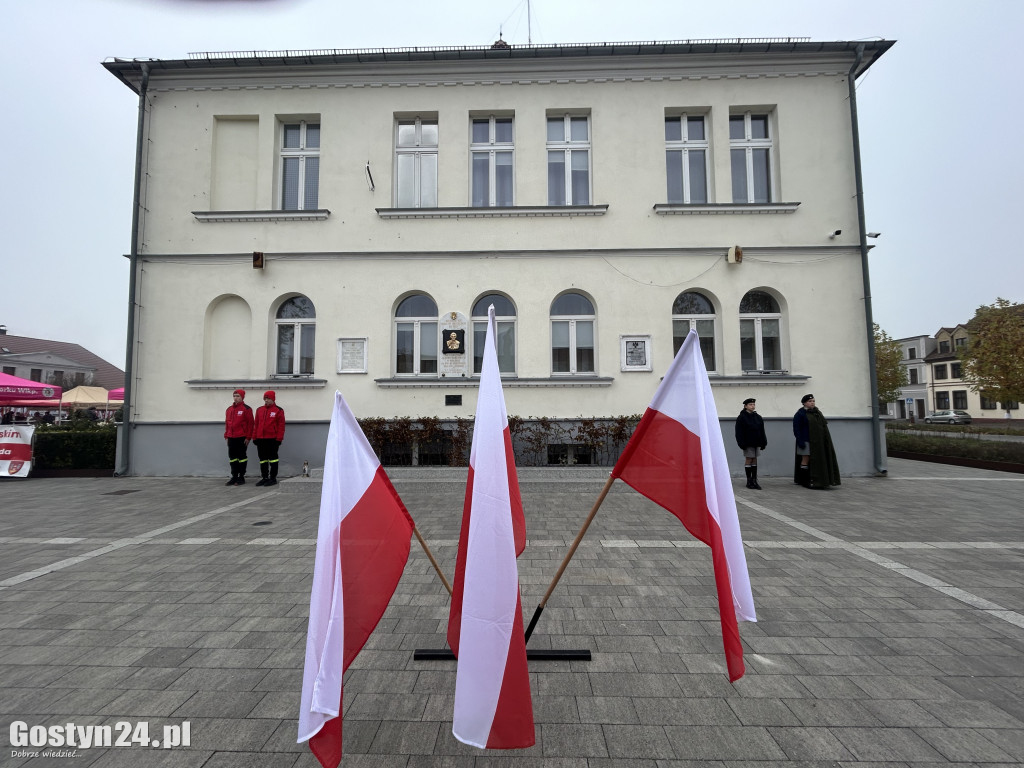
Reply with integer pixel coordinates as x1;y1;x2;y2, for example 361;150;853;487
104;39;893;475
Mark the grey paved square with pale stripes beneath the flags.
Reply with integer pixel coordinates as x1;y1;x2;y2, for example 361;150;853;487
0;460;1024;768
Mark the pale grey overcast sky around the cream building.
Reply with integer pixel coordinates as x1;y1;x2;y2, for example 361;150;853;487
0;0;1024;368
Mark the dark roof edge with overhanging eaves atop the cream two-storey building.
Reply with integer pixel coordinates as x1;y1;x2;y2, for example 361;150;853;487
103;37;895;93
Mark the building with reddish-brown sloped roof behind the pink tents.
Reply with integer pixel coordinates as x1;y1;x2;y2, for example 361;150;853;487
0;326;125;389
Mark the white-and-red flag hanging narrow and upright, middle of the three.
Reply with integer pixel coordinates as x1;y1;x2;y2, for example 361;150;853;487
447;306;536;750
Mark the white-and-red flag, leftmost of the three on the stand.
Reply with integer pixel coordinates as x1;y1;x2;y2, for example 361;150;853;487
298;392;414;768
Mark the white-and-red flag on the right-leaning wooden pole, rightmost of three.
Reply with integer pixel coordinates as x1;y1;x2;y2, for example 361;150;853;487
611;331;757;682
